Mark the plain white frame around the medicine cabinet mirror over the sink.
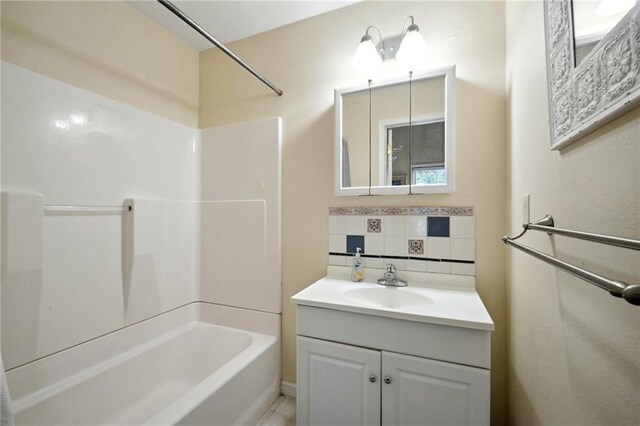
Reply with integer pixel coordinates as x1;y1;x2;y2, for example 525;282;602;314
333;65;456;195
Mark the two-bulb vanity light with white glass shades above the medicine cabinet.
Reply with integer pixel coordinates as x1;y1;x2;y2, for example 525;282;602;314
351;16;427;78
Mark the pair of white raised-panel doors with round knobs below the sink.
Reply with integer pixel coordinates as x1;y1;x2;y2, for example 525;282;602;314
297;337;490;426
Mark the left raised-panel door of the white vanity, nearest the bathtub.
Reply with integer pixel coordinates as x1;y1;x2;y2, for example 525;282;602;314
297;337;380;426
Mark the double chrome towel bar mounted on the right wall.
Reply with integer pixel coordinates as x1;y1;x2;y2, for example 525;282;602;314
502;215;640;305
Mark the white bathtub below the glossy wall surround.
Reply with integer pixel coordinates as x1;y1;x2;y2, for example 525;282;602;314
7;302;280;425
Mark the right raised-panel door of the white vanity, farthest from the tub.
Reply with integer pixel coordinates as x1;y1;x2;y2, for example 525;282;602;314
382;352;490;426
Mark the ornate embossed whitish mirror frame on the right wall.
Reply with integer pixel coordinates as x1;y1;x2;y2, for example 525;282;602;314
544;0;640;150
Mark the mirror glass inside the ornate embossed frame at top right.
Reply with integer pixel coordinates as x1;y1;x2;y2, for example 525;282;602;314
571;0;636;66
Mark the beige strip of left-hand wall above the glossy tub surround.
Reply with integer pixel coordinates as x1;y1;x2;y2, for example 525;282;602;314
2;1;198;127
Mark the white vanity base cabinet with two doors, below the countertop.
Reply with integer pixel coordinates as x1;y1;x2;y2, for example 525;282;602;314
296;302;491;426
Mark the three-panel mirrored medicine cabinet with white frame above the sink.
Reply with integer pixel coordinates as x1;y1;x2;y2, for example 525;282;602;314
334;66;455;195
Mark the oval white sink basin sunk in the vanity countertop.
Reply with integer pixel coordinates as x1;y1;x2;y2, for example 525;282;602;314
343;287;433;309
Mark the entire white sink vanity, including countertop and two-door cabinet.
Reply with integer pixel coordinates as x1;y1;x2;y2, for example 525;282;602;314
292;277;493;426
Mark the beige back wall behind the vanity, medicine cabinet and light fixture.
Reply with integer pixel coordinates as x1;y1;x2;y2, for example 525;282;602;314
199;2;507;424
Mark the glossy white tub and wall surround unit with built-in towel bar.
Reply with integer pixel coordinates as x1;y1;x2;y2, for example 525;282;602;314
2;63;281;424
